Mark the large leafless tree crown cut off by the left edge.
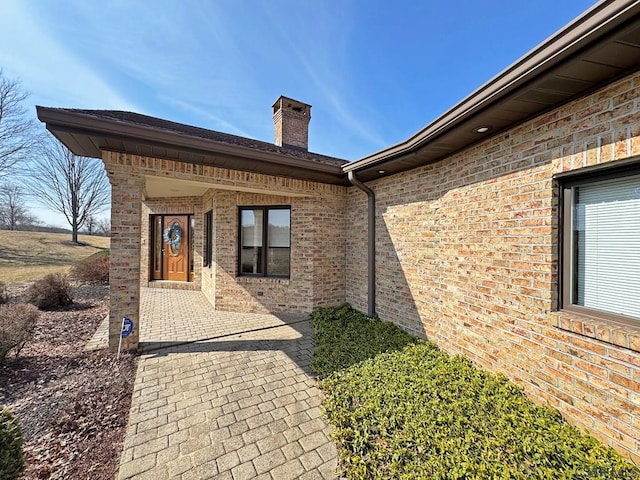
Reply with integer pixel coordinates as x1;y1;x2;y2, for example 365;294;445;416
0;70;41;177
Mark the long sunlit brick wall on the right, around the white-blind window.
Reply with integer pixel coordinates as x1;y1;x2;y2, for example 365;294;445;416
346;74;640;463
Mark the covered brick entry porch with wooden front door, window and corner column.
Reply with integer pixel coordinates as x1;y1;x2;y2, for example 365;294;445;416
103;152;345;350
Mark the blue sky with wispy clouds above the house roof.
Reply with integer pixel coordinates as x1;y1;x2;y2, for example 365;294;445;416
0;0;594;224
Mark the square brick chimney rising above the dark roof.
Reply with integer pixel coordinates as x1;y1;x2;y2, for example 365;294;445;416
273;96;311;150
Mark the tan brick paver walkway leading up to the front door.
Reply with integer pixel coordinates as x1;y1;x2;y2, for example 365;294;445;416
118;289;337;480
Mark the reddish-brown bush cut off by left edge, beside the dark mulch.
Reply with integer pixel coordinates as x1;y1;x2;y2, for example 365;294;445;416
0;303;40;361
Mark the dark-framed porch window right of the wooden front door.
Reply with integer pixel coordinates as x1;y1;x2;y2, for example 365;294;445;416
238;206;291;278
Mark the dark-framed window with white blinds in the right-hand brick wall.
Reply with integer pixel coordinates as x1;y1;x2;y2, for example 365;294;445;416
561;167;640;325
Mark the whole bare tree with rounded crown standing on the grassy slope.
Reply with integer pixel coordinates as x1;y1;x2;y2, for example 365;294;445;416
26;141;111;243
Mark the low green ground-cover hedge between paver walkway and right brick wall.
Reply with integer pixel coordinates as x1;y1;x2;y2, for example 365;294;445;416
313;307;640;480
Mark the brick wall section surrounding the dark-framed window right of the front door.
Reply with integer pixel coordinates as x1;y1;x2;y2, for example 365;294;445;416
213;190;346;314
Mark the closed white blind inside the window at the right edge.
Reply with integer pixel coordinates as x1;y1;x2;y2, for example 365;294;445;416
573;175;640;319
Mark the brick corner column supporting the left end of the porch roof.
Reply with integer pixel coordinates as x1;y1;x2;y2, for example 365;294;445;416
103;152;144;351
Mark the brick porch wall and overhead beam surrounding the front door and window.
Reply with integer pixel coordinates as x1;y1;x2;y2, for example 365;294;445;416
103;152;347;326
